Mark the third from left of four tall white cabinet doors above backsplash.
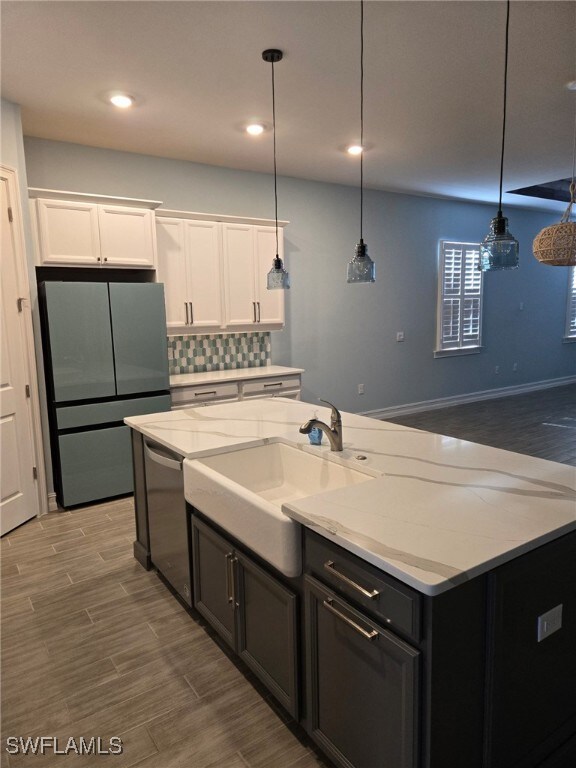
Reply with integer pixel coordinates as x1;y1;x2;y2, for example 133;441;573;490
222;224;257;326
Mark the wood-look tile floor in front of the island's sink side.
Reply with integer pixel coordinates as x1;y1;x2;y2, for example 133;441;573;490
0;499;326;768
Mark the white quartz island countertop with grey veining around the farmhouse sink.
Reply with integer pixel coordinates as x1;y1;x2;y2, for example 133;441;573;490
125;398;576;595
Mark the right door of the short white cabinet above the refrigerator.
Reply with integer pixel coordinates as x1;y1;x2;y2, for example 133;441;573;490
98;205;156;268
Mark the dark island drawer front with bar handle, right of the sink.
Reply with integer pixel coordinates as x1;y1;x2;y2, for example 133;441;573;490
305;531;421;641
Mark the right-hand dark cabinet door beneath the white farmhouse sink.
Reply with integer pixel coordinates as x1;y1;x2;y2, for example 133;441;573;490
236;552;298;719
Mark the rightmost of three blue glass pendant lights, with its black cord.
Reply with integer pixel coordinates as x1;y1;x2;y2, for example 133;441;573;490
478;0;518;272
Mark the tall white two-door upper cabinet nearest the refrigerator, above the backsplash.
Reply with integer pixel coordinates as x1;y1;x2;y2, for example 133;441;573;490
156;218;222;333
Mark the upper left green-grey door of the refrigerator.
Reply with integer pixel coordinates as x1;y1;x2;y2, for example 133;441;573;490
44;282;116;403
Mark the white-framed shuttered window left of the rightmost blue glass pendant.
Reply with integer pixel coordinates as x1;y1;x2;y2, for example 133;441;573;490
435;240;483;357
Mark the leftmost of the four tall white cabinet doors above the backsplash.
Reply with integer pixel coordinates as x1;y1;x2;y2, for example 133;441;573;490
156;218;190;331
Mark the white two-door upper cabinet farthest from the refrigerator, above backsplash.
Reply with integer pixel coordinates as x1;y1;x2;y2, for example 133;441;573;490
222;224;284;329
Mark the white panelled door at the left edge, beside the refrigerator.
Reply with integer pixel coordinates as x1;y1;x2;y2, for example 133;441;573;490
0;178;39;535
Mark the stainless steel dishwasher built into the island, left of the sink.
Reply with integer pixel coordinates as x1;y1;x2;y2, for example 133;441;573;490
144;439;192;605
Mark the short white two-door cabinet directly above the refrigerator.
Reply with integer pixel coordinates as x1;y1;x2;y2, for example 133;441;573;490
30;190;160;269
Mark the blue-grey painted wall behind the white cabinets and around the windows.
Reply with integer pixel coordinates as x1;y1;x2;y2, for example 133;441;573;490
25;138;576;412
